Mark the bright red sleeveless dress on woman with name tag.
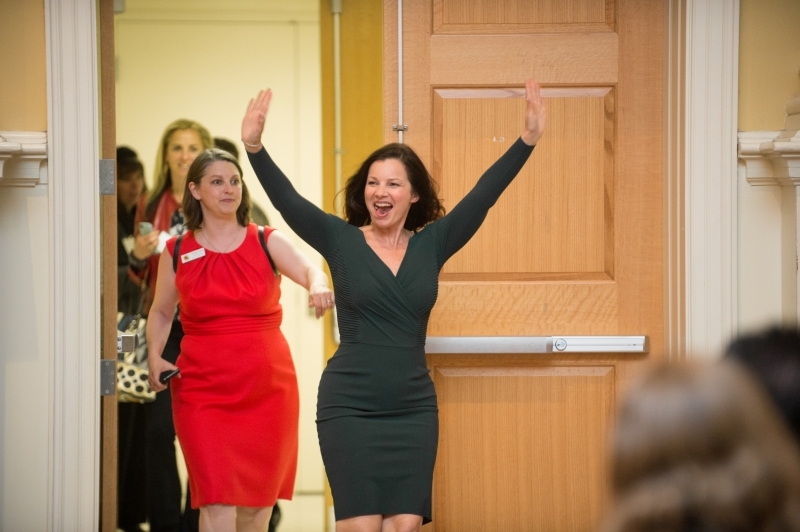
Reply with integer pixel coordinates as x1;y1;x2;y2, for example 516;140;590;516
167;224;300;508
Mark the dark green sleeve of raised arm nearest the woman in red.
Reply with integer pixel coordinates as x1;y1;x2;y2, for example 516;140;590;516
247;148;346;257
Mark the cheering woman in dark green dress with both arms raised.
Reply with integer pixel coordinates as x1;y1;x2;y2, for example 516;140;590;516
242;80;546;532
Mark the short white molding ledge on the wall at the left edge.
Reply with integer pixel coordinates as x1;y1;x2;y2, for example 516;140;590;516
0;131;47;187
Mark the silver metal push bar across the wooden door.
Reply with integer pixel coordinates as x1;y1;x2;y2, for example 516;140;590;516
425;336;648;354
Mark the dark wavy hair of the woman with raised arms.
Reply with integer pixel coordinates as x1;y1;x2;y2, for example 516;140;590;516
344;143;444;233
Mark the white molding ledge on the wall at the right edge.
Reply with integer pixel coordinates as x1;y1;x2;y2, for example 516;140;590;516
738;96;800;187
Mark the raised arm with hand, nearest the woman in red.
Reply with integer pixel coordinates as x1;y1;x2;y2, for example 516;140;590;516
242;90;344;256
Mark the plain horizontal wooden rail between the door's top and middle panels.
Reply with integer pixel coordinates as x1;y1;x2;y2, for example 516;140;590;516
432;33;619;86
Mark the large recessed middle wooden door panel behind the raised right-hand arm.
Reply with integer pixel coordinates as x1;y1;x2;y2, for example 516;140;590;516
433;91;613;279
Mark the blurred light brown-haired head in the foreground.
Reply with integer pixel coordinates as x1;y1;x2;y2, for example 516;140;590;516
602;364;800;532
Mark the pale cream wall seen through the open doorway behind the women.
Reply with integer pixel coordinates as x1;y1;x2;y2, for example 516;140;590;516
115;0;323;493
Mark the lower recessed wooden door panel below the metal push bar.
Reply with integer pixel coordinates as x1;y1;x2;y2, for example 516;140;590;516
434;366;614;532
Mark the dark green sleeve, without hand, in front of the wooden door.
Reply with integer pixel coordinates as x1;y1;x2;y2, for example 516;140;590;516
436;138;533;268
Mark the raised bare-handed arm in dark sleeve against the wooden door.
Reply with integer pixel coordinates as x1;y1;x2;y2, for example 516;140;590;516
437;79;547;267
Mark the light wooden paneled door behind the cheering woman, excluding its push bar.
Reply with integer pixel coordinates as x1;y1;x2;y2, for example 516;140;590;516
384;0;666;532
